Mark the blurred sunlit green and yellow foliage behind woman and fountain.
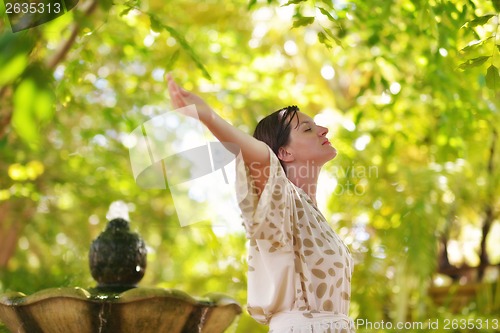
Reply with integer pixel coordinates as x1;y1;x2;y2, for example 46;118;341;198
0;0;500;333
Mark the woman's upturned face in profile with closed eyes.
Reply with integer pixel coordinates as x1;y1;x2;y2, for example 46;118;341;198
284;112;337;166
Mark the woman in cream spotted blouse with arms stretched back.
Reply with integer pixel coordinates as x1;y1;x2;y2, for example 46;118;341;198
168;75;353;333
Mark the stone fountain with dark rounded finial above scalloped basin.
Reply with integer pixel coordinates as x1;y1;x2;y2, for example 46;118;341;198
0;207;241;333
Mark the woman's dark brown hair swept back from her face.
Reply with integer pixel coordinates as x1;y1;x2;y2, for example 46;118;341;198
253;105;300;163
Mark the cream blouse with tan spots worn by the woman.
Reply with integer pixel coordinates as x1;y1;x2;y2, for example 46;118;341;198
236;150;353;332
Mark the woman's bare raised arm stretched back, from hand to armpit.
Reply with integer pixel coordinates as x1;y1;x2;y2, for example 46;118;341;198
167;74;269;193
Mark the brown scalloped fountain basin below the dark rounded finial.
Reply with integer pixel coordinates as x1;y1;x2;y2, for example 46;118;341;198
0;287;241;333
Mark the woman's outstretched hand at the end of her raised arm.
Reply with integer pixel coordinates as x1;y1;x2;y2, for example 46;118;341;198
167;73;212;122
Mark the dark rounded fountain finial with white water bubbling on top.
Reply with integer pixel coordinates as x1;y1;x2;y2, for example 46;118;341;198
89;201;147;292
